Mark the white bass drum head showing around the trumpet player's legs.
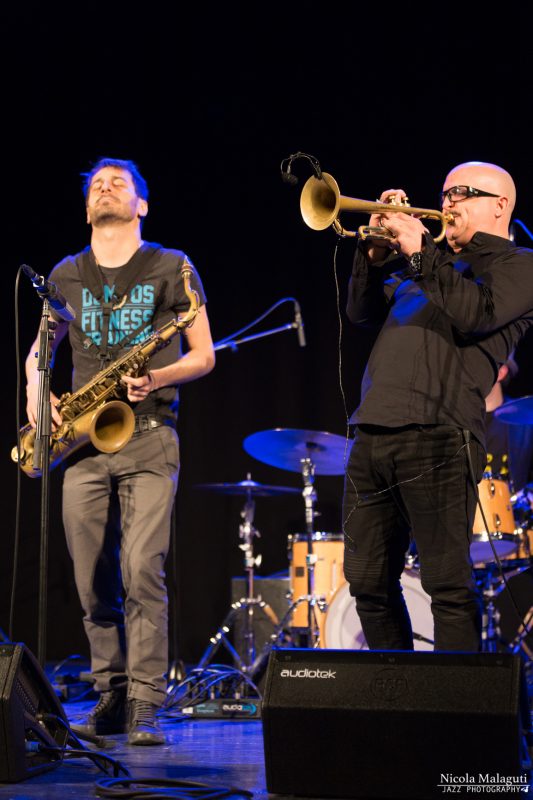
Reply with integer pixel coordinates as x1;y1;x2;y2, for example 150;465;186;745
323;571;433;650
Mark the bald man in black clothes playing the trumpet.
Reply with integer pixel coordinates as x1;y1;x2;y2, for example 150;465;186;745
343;162;533;651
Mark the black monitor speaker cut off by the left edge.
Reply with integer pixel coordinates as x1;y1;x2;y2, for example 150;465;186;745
0;644;68;783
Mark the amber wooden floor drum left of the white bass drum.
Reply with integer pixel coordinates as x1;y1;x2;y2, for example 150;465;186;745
288;531;345;641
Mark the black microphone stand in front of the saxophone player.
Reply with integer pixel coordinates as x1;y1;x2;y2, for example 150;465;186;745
33;297;55;669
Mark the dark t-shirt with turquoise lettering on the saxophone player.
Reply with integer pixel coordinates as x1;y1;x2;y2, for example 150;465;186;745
50;245;205;419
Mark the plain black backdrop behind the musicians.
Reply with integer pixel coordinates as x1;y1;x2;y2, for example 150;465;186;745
0;14;533;662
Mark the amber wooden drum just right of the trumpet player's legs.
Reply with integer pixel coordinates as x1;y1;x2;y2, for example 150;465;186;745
470;478;519;564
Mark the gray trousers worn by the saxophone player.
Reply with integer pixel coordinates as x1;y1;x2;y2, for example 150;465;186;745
63;426;179;705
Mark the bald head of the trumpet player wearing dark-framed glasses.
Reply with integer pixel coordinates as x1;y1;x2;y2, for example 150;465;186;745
443;161;516;251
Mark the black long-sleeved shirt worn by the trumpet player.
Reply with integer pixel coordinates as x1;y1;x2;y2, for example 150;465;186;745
347;233;533;443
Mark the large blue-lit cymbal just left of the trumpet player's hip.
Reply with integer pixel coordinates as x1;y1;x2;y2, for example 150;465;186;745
243;428;348;475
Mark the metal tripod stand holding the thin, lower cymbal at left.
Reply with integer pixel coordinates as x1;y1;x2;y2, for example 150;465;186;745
197;474;279;676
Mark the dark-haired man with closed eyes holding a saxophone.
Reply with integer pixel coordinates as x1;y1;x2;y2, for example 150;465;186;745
22;158;215;745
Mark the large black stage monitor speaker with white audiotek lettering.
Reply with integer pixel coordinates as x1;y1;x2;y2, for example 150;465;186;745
263;649;530;800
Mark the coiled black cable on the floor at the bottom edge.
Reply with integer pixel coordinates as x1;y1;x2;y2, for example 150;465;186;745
96;778;253;800
